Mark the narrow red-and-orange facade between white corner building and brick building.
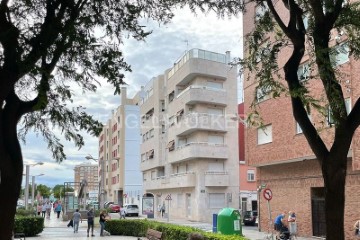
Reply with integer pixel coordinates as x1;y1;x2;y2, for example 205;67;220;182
238;103;258;215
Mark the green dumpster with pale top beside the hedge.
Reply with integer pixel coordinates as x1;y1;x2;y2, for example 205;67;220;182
217;208;242;235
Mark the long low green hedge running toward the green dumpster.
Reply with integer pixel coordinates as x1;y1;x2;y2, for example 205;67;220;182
105;219;246;240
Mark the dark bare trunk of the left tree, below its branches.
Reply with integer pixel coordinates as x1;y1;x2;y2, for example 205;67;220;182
0;109;23;240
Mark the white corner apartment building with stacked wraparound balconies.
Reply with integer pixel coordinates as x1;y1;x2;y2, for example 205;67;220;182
140;49;239;222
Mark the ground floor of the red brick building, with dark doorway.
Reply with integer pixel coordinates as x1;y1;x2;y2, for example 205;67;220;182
257;159;360;239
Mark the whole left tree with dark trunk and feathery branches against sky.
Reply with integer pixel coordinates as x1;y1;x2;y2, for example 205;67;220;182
0;0;193;239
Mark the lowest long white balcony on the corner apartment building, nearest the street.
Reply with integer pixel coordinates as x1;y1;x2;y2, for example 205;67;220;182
143;172;196;190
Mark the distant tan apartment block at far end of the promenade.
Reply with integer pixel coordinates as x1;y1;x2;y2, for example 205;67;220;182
74;163;99;193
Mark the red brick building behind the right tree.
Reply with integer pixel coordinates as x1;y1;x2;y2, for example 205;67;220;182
243;2;360;239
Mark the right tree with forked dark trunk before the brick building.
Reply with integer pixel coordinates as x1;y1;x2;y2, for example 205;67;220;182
235;0;360;240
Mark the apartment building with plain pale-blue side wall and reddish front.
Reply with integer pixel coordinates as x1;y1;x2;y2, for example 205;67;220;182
98;87;143;207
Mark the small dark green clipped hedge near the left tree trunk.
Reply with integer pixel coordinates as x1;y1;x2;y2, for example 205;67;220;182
14;217;44;237
